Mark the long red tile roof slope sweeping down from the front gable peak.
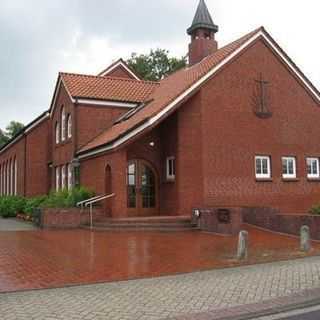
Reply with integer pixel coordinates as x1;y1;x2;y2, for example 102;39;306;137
79;28;263;154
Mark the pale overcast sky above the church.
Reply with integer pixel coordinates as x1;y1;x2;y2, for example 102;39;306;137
0;0;320;128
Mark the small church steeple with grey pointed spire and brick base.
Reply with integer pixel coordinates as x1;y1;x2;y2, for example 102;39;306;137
187;0;219;65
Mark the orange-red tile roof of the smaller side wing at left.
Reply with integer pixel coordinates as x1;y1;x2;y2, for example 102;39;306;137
60;73;159;102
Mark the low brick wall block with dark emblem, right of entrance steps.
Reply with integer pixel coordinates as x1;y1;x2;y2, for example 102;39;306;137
194;208;242;235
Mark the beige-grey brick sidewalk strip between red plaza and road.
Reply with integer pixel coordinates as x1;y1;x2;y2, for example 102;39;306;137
0;257;320;320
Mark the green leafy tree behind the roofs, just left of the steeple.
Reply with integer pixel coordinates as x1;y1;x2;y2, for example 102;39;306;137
127;49;187;81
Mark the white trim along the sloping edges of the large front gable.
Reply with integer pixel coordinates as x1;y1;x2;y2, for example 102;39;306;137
79;30;320;159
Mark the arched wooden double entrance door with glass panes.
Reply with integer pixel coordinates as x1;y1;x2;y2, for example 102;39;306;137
127;160;158;217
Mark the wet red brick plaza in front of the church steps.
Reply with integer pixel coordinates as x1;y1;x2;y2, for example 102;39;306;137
0;226;320;292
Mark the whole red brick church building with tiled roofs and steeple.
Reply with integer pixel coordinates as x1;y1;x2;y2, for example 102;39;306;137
0;0;320;218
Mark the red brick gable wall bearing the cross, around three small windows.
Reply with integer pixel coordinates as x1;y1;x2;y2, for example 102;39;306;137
201;37;320;212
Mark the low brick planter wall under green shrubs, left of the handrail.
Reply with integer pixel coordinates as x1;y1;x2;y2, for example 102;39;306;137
41;208;105;229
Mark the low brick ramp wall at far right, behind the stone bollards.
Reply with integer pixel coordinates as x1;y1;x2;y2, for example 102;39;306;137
243;208;320;240
